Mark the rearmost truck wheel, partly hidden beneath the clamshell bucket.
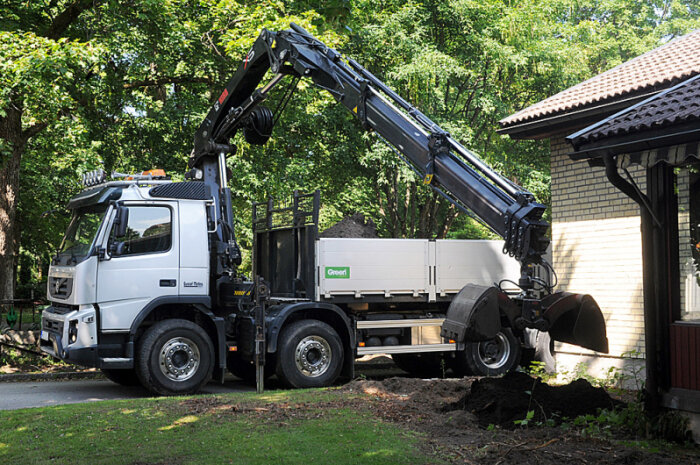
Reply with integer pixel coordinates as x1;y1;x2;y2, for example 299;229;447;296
456;328;521;376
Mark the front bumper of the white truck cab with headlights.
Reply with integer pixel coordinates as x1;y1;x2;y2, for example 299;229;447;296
40;305;102;368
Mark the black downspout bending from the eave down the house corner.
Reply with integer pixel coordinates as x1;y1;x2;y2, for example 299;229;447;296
603;154;660;414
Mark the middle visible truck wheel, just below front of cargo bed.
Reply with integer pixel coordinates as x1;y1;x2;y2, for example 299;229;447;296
277;320;344;388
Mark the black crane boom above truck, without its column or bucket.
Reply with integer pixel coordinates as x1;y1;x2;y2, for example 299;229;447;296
190;24;549;264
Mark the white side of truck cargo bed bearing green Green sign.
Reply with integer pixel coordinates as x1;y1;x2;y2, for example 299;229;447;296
316;238;520;302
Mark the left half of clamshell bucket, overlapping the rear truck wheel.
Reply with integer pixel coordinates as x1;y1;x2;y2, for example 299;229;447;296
440;284;501;342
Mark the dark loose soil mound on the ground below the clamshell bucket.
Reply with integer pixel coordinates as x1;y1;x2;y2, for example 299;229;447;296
446;372;622;429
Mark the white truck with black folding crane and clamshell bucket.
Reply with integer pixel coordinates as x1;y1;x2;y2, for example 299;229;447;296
41;24;608;395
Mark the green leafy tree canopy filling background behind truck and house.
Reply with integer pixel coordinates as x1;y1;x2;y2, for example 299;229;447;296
0;0;700;297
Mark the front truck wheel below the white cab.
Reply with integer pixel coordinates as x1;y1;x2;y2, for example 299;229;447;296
136;319;214;396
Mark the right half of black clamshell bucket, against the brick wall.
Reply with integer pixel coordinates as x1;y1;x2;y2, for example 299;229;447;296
542;292;608;354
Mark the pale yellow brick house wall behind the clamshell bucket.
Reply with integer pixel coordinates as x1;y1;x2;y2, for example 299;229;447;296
550;135;646;357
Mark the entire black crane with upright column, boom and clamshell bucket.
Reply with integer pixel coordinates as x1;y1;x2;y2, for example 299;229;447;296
194;24;608;352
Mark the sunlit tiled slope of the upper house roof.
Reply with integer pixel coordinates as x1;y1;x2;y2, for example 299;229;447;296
499;30;700;128
